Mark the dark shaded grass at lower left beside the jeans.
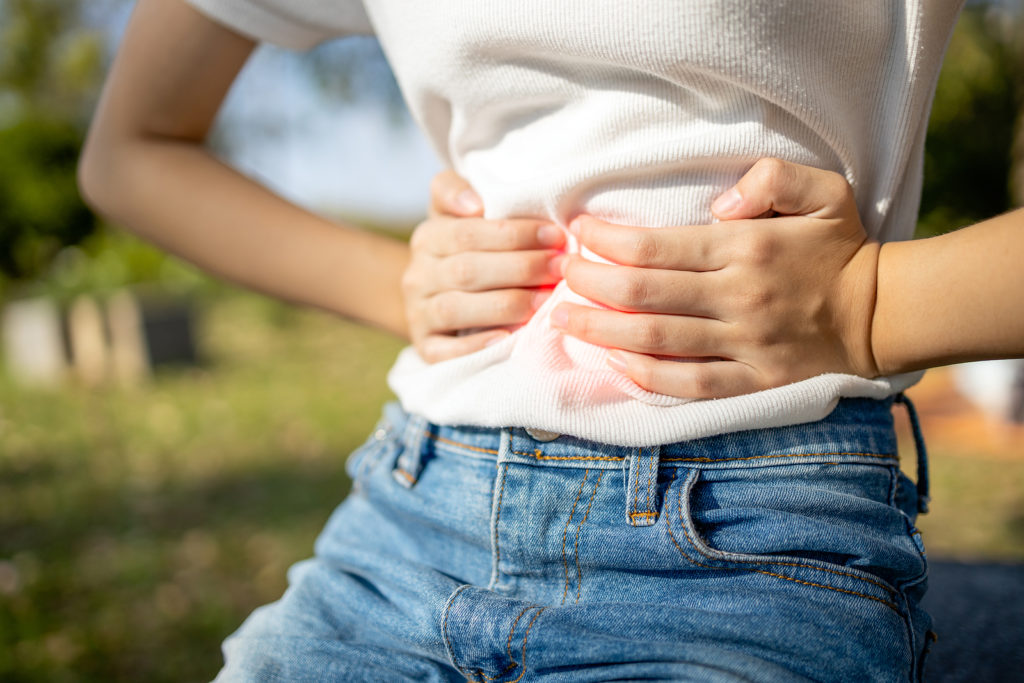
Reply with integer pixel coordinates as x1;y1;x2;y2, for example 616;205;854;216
0;456;360;682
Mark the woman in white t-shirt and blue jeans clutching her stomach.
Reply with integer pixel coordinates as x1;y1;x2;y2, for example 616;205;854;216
81;0;1024;681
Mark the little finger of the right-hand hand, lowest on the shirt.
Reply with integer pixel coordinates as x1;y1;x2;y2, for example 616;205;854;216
608;350;767;398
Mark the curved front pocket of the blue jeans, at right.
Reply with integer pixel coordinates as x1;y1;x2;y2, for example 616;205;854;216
667;463;925;603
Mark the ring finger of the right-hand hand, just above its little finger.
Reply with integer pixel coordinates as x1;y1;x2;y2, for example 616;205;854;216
551;303;731;357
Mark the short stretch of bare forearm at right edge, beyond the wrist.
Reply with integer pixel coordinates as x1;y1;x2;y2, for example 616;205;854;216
871;209;1024;375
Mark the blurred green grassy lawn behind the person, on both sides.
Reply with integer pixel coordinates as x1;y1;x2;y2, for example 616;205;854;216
0;292;1024;682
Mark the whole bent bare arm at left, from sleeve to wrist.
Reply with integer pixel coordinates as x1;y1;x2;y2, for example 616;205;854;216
79;0;409;334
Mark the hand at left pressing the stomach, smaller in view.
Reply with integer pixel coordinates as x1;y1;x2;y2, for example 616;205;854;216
401;170;565;362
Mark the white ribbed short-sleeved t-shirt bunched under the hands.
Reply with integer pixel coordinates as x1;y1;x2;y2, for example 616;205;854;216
188;0;964;446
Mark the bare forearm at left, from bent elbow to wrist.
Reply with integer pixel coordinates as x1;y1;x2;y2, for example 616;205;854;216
82;138;409;336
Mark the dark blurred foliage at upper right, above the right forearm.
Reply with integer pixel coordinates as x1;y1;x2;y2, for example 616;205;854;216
918;4;1024;237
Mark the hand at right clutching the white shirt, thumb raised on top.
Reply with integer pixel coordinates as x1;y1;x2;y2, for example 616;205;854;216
551;159;879;398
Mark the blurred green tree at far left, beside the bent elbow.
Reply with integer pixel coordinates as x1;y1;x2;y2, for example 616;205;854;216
0;0;105;286
